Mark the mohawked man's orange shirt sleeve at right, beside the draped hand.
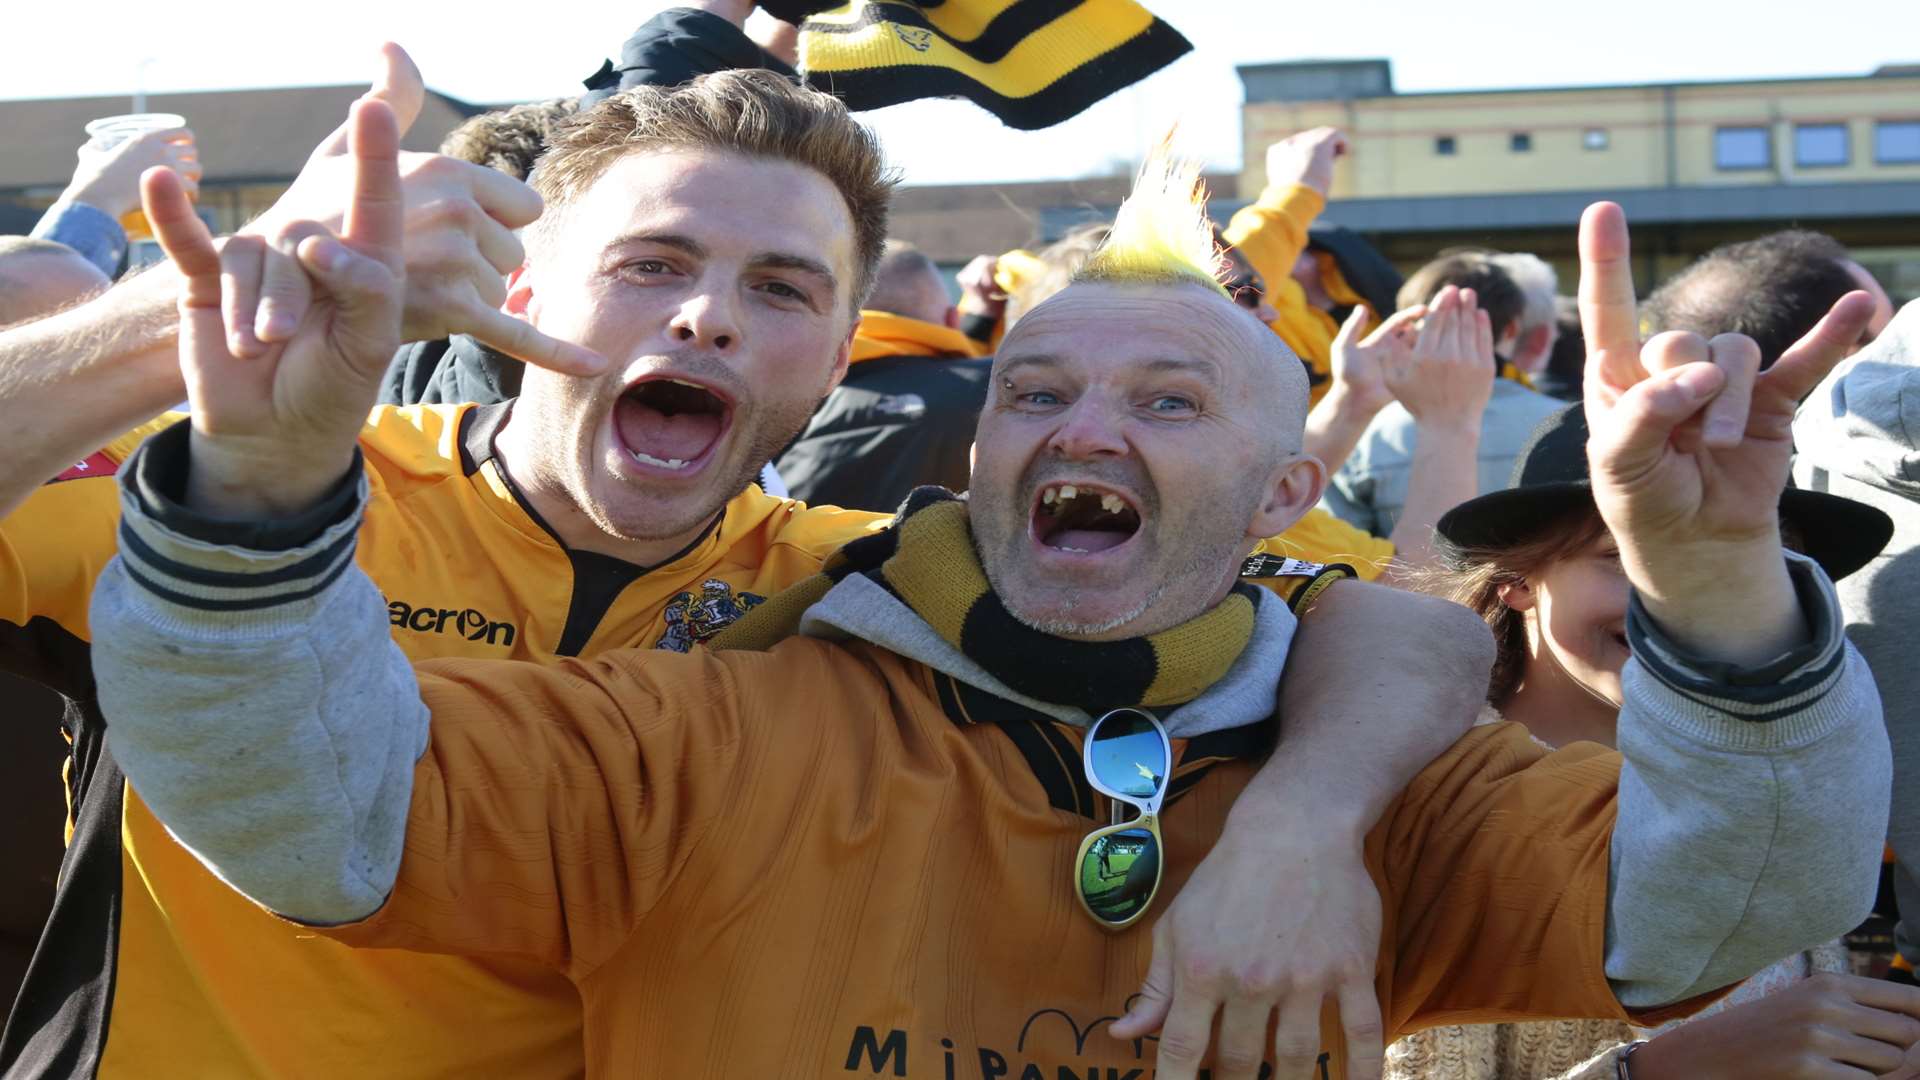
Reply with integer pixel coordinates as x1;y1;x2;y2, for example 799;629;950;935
1367;723;1628;1036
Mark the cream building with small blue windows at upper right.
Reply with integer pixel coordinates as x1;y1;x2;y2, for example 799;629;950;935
1240;60;1920;298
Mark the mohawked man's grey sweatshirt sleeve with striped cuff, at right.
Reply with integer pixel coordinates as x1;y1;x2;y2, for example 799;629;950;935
1607;555;1893;1009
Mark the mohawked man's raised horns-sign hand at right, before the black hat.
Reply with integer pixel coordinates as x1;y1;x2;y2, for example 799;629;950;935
1580;202;1874;663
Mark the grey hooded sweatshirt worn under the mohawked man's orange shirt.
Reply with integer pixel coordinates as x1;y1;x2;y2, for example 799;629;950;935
92;438;1891;1007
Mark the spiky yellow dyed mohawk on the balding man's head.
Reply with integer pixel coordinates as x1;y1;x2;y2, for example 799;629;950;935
1073;135;1227;296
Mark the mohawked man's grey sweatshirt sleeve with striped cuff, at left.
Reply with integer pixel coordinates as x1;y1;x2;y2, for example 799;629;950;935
90;424;428;924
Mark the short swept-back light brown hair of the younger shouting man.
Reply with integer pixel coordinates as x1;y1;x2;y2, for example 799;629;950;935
528;69;897;309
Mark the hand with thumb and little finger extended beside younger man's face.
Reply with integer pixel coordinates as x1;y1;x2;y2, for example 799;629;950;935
225;42;605;375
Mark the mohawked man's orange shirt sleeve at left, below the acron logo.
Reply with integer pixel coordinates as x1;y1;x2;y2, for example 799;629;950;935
324;638;764;974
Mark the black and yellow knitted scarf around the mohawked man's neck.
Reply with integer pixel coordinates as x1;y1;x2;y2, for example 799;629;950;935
710;488;1256;713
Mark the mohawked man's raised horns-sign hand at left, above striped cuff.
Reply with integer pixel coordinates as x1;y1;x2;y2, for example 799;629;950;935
142;100;405;521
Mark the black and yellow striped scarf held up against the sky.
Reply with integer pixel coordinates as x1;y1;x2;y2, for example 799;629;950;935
760;0;1192;131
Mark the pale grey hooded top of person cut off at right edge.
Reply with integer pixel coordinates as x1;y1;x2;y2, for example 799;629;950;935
1793;302;1920;963
